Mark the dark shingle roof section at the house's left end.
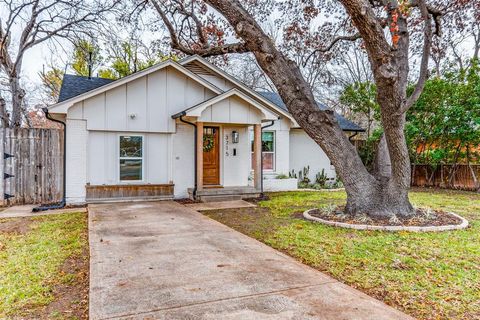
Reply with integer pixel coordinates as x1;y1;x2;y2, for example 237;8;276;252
58;74;115;102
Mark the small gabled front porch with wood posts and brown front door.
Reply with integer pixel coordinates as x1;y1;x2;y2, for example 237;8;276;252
172;89;278;202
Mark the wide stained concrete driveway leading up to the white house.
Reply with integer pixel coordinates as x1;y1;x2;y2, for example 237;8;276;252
89;201;411;320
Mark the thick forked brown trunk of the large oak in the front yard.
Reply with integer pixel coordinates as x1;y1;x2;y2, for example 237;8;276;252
202;0;413;217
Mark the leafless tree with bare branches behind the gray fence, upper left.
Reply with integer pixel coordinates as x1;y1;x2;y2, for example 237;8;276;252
0;0;120;126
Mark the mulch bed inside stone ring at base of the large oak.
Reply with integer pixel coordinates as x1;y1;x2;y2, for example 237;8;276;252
309;206;462;227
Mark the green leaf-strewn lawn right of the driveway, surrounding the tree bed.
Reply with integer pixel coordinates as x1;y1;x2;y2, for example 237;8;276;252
206;190;480;319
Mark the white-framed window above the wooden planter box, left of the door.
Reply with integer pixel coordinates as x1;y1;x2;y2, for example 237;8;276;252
119;136;143;181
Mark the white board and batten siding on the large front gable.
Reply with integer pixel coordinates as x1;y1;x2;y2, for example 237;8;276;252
67;67;214;133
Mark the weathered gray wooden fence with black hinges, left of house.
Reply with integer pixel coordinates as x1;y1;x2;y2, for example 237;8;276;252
0;128;63;205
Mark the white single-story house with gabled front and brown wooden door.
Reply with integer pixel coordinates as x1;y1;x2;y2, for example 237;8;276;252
49;56;363;203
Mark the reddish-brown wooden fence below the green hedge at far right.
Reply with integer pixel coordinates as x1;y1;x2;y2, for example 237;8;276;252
412;164;480;192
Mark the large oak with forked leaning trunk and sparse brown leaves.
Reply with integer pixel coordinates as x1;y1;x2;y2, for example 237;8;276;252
148;0;478;217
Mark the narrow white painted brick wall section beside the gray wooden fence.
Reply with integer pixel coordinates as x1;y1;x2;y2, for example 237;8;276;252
66;119;88;204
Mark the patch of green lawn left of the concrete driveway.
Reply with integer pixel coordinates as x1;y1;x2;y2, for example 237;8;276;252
0;213;88;319
